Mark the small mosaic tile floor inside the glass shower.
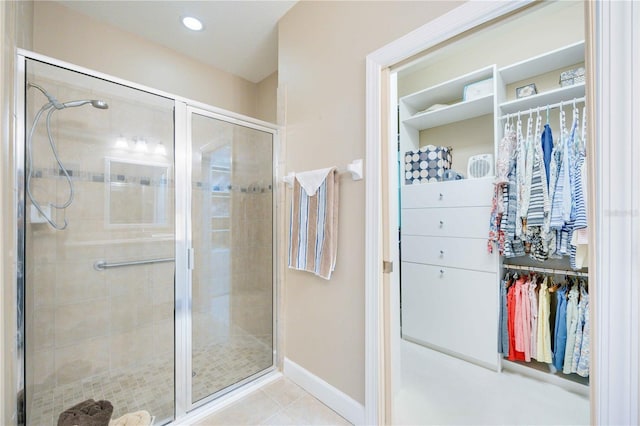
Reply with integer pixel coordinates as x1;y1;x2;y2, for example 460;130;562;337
27;333;273;426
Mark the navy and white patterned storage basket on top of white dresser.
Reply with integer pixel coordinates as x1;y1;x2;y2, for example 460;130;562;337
404;145;451;185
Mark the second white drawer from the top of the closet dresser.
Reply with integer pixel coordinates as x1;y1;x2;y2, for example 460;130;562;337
401;206;491;238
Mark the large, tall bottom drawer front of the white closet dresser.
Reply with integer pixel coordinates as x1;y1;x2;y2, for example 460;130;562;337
401;262;499;368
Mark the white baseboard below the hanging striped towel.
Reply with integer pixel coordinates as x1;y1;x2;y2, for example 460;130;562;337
283;358;364;425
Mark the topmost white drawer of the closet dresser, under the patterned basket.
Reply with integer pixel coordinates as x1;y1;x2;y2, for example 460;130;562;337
402;178;493;208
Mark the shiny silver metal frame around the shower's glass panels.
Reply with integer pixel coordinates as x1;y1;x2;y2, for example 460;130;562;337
13;49;281;424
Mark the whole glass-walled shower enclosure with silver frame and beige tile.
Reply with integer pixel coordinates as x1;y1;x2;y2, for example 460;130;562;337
17;52;276;425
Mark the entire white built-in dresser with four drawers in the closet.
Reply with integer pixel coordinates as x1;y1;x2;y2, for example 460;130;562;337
400;178;500;370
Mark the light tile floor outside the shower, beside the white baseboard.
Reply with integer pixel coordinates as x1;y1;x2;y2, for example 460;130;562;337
194;377;351;426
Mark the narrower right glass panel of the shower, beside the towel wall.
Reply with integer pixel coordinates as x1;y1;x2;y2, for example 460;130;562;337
191;113;273;403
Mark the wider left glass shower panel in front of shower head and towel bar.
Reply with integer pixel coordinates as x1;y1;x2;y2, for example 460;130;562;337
24;60;175;426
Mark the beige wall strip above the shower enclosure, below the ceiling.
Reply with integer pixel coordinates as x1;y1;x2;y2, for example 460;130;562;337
33;1;275;119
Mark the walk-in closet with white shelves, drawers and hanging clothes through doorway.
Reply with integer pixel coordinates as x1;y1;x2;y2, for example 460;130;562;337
396;2;591;424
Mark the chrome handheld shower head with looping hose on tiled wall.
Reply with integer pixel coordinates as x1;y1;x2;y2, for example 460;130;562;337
25;82;109;230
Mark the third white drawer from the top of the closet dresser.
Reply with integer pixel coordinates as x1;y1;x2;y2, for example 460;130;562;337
400;235;498;272
